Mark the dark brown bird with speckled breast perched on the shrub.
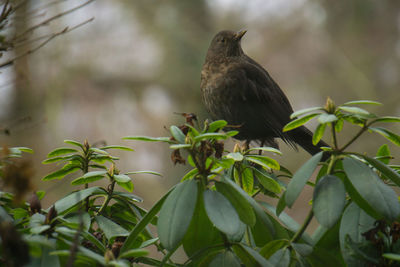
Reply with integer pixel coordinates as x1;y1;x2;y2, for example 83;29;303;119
200;30;328;155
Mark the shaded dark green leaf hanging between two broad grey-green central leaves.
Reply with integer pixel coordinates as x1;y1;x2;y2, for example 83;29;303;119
183;183;222;257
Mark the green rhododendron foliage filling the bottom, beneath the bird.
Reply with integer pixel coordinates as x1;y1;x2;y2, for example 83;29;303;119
0;99;400;266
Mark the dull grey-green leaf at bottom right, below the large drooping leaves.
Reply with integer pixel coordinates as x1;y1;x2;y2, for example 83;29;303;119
339;202;375;266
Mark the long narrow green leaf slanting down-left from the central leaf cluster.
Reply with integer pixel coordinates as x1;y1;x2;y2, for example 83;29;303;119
120;187;175;253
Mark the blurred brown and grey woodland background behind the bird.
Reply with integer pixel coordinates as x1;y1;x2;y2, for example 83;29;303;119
0;0;400;237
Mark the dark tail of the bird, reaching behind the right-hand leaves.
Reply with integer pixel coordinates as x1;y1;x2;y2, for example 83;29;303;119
288;126;329;160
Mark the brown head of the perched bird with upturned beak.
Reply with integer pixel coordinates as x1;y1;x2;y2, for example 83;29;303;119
207;31;246;57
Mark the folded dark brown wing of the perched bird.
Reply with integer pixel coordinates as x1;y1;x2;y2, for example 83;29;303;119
226;60;293;144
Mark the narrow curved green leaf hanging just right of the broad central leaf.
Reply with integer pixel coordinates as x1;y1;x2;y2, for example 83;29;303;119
215;181;256;226
